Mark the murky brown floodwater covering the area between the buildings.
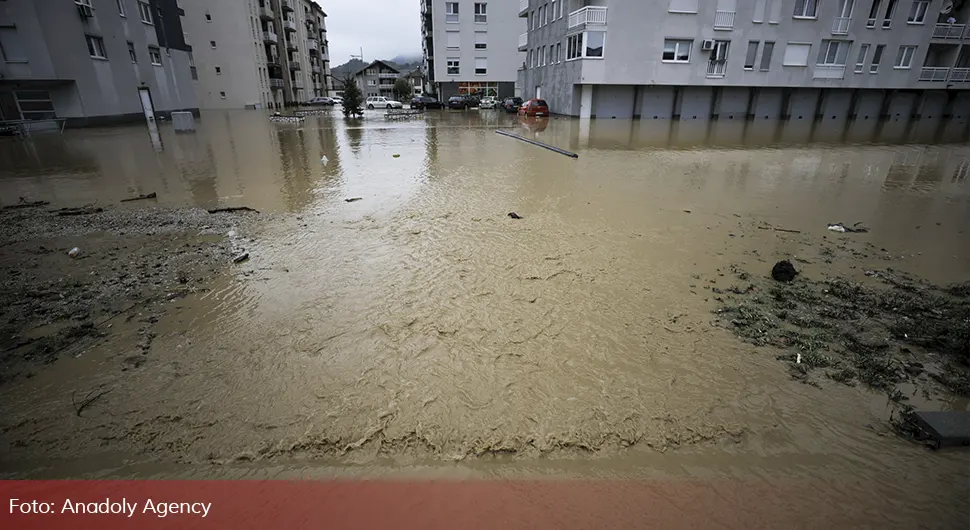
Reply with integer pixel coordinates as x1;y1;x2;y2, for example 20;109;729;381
0;111;970;527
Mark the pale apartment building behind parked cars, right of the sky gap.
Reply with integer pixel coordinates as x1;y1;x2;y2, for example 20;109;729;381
421;0;525;98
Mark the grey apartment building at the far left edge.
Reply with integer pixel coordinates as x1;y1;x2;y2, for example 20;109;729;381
0;0;198;127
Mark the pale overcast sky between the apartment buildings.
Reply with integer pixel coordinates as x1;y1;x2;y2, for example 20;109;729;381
326;0;421;66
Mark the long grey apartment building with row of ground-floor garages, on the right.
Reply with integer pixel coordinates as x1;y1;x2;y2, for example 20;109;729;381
518;0;970;119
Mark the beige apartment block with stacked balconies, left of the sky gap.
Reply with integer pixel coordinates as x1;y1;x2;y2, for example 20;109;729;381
184;0;332;109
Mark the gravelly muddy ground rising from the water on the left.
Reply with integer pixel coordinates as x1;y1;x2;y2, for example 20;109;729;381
0;201;257;384
